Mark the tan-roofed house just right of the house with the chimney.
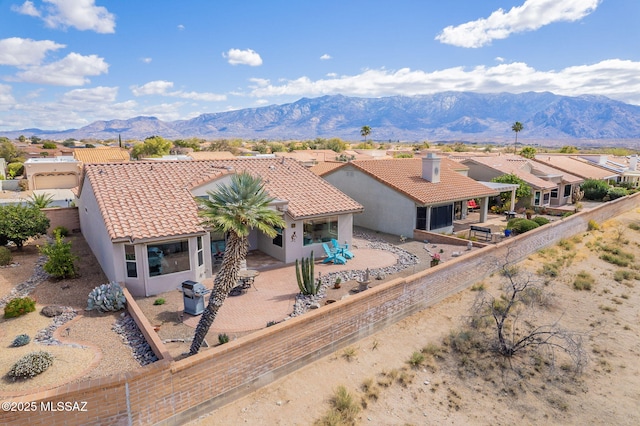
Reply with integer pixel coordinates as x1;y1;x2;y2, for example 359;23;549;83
461;154;584;207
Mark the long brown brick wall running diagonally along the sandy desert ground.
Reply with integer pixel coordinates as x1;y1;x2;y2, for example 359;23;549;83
0;193;640;425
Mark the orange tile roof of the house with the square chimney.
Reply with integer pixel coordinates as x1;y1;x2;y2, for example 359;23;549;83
348;158;497;205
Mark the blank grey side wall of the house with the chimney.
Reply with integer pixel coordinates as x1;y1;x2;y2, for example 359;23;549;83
324;166;416;235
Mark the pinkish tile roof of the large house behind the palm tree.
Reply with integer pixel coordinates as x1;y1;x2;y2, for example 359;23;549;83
80;158;362;240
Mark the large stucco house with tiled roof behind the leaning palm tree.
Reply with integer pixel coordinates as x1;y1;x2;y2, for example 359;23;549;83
78;158;362;296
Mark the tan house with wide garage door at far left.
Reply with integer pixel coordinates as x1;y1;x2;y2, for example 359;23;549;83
24;157;82;190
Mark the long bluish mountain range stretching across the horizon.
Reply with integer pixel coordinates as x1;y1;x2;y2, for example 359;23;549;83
3;92;640;146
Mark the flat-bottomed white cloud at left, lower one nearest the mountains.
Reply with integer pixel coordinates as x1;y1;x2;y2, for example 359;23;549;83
9;53;109;86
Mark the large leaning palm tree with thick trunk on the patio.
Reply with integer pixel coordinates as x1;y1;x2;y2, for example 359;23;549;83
189;172;285;355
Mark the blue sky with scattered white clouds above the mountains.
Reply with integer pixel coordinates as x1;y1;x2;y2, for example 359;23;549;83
0;0;640;131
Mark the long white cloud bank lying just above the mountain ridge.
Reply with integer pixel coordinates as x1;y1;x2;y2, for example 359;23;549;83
245;59;640;104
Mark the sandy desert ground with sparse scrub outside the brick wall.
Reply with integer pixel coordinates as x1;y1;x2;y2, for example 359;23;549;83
190;210;640;425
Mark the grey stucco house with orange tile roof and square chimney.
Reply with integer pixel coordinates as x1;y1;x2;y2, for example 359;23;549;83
322;154;500;236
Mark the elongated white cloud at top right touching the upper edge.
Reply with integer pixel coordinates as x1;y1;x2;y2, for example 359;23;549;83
436;0;602;48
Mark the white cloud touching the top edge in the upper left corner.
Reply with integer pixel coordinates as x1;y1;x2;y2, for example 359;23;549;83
12;0;116;34
